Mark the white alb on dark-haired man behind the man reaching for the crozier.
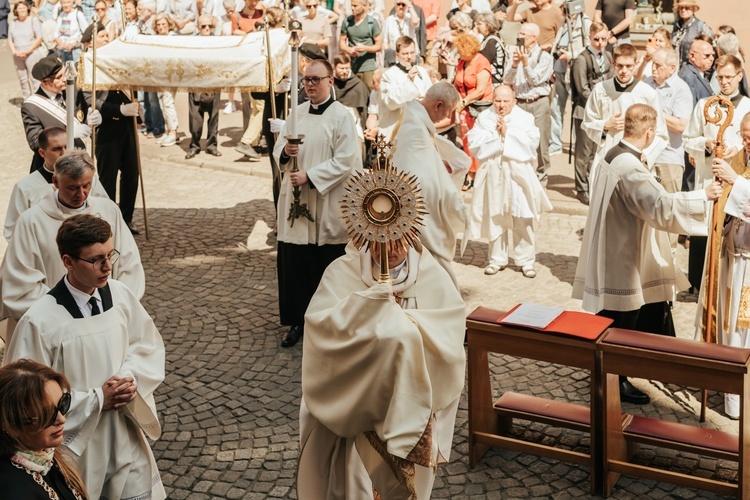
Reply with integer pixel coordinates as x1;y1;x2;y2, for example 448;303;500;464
582;78;669;186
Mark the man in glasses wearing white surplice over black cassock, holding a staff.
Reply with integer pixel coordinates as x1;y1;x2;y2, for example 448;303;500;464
273;61;362;347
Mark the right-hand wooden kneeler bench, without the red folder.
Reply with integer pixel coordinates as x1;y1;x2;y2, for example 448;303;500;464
598;328;750;499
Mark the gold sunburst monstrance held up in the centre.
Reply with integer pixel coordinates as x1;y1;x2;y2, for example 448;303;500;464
341;135;427;283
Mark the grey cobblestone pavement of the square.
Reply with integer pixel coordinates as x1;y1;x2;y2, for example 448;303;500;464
0;41;737;500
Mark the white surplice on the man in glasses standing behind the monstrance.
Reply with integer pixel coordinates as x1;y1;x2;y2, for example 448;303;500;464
273;101;362;245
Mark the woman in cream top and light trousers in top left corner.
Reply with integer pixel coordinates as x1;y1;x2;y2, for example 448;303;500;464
8;1;42;99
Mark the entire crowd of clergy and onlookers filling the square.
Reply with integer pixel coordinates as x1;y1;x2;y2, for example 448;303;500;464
0;0;750;499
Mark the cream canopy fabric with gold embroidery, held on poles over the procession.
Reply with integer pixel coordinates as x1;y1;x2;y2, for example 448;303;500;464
78;29;290;92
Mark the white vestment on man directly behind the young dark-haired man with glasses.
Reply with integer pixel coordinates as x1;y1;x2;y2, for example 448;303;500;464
0;191;146;321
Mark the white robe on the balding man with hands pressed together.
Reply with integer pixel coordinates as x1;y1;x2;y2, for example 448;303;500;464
468;106;552;241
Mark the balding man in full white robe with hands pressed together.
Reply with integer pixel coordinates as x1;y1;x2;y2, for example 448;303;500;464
468;85;552;278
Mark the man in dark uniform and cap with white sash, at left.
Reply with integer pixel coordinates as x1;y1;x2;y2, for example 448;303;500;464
21;54;91;172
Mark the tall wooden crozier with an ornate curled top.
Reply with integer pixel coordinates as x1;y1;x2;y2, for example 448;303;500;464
700;94;734;422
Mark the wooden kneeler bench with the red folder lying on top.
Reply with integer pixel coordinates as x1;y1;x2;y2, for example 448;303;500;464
466;307;603;494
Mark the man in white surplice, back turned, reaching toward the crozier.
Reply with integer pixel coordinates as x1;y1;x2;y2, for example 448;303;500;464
573;104;721;404
